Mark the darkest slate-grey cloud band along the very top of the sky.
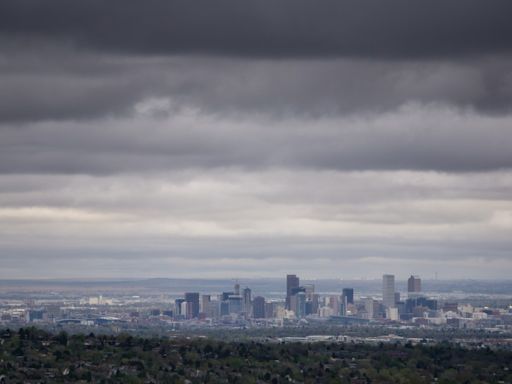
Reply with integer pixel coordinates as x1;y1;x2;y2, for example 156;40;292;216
0;0;512;58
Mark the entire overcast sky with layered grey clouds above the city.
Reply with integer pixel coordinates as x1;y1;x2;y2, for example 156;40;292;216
0;0;512;279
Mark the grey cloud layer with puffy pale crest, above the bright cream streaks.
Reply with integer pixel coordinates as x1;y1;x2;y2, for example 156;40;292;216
0;104;512;174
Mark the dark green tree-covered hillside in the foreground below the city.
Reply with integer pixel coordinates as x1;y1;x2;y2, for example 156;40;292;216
0;328;512;383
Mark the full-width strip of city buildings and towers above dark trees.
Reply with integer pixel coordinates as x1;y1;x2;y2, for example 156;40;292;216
0;274;512;328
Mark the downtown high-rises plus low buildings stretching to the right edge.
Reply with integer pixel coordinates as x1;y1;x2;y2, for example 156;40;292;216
161;274;512;328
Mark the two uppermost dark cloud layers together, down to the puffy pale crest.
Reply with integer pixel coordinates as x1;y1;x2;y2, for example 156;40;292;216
0;0;512;122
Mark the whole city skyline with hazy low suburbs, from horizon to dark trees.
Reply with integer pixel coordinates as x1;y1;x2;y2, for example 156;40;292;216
10;274;512;332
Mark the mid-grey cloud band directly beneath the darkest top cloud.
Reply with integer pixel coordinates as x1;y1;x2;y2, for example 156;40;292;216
0;52;512;122
